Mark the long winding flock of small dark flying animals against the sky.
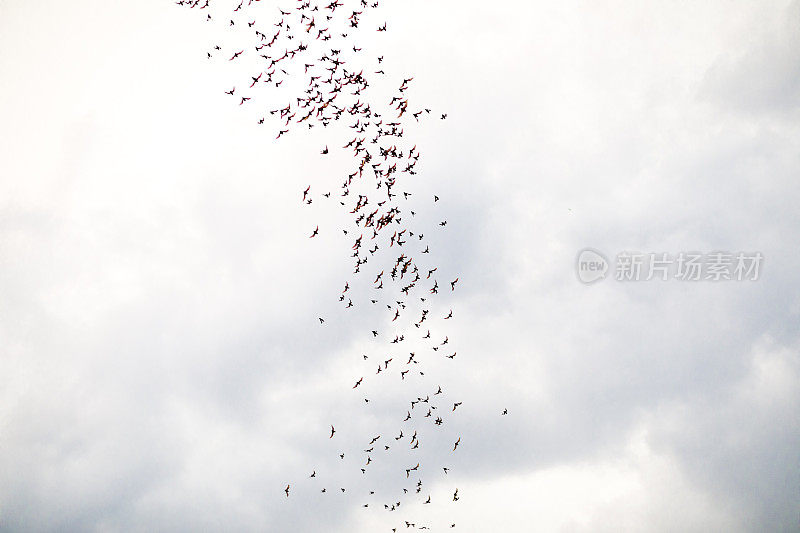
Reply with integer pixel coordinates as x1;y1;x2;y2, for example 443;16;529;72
176;0;508;531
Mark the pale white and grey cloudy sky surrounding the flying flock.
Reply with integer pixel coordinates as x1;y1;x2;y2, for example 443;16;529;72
0;0;800;533
